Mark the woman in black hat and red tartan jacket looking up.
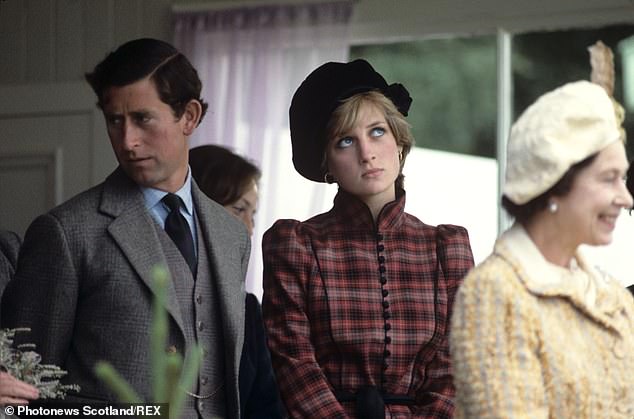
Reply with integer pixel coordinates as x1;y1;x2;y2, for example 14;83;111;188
263;60;473;418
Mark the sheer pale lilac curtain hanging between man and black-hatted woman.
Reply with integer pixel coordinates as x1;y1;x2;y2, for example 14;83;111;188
173;1;353;297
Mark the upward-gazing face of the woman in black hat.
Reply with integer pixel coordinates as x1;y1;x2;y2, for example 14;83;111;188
326;102;401;208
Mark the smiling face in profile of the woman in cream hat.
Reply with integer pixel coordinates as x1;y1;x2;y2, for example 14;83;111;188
554;141;632;246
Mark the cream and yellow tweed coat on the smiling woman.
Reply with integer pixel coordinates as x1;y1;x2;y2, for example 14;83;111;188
450;225;634;419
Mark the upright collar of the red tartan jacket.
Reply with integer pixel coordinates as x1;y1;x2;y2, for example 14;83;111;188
332;189;405;231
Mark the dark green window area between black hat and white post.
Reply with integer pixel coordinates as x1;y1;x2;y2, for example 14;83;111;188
350;36;497;157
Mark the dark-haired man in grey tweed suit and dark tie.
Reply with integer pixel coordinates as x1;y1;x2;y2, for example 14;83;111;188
2;39;250;418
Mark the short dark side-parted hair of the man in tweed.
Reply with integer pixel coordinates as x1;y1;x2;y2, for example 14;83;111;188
86;38;208;121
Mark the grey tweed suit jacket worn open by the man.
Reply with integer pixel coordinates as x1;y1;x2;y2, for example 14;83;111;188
2;168;250;417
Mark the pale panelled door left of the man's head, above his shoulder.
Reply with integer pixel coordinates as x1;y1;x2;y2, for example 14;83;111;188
0;83;116;236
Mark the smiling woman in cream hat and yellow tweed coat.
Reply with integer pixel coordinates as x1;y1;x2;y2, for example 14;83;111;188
450;81;634;419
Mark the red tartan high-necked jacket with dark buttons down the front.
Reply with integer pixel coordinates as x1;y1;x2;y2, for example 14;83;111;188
262;190;473;419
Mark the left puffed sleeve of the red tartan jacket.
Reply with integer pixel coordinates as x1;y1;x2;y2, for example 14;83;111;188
262;220;345;418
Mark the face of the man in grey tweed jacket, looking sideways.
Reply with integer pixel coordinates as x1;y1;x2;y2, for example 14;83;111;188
103;78;191;192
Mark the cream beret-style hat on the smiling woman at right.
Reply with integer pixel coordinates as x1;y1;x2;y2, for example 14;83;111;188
503;81;622;205
